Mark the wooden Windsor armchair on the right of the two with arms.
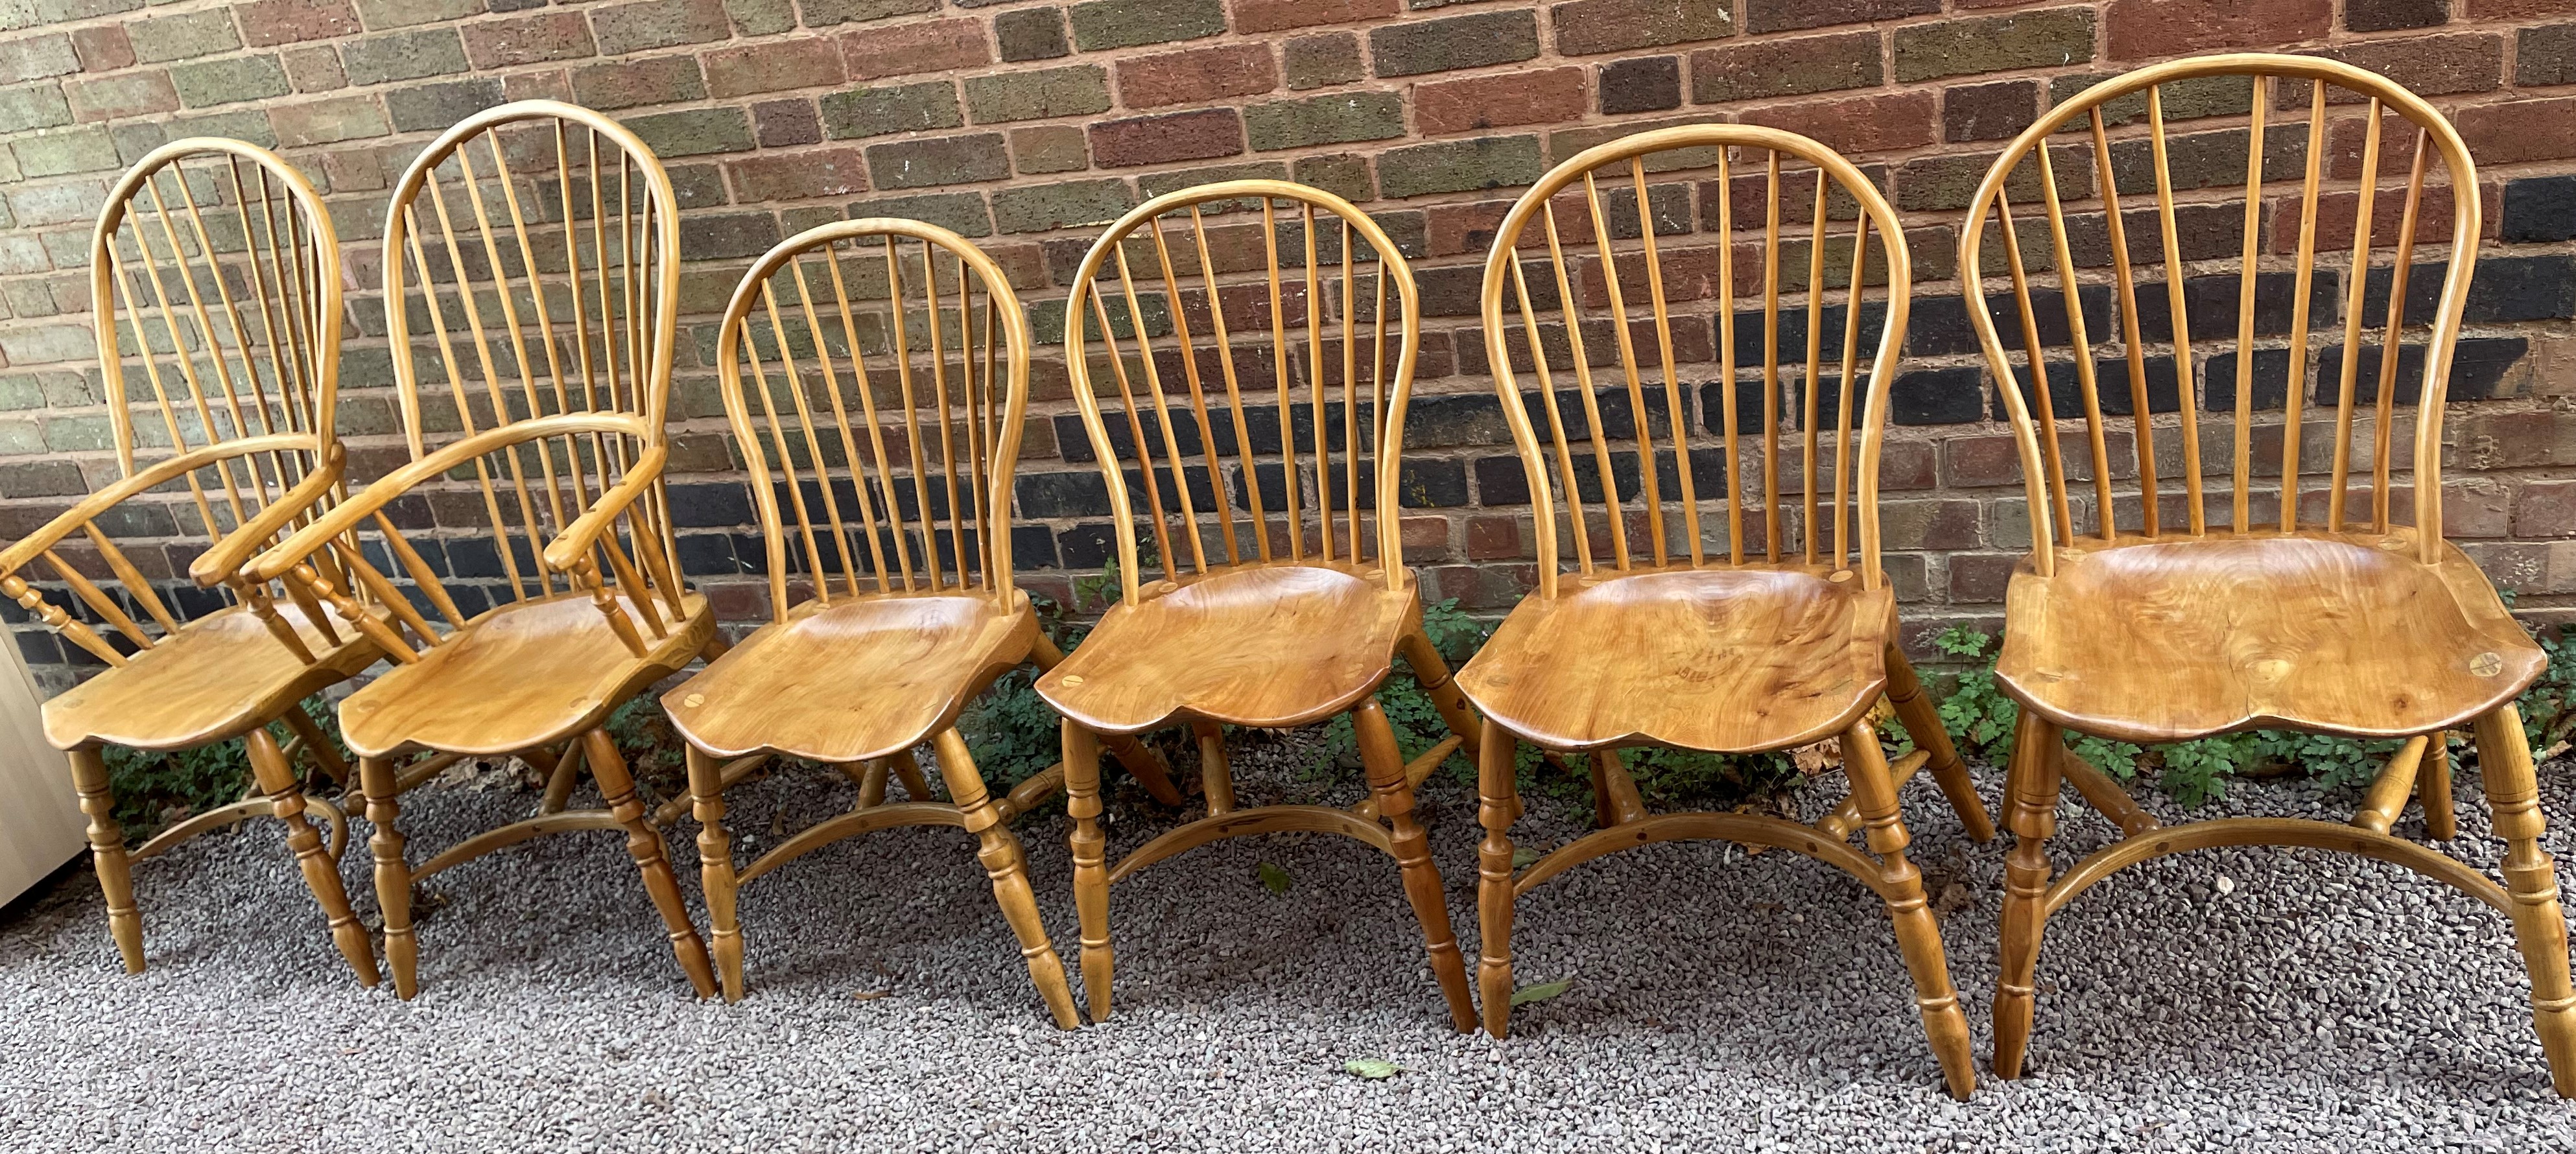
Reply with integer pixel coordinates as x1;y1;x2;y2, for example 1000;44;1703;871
247;100;721;997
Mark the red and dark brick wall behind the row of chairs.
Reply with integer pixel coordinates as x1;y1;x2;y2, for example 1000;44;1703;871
0;0;2576;685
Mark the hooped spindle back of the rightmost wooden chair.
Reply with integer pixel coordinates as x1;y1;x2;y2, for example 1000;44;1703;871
1957;51;2483;574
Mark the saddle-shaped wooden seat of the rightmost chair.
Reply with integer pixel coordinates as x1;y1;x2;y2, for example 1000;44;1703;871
1994;528;2547;742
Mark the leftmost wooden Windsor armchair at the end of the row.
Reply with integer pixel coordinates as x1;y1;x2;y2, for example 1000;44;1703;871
23;139;379;987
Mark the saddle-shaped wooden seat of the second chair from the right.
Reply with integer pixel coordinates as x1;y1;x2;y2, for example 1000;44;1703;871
1458;567;1896;752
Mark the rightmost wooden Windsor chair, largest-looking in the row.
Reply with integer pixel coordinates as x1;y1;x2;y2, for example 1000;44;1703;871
1960;54;2576;1095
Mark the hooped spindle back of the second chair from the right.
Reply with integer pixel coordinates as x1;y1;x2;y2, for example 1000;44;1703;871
1483;124;1914;598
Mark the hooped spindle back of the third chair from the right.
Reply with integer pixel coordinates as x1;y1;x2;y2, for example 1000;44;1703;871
1059;180;1422;600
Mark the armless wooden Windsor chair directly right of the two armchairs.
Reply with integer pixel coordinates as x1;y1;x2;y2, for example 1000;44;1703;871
662;219;1170;1028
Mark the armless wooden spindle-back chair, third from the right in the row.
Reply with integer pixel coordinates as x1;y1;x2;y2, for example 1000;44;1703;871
1038;180;1476;1030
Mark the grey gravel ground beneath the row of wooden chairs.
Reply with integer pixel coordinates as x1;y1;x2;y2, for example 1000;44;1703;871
0;736;2576;1154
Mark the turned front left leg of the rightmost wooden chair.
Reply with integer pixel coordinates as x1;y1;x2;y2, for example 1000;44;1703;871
1994;709;2063;1079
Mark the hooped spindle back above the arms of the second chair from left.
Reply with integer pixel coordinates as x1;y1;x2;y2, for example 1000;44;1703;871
384;100;680;461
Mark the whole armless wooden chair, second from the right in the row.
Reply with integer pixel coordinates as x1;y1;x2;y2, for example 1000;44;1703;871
1458;124;1994;1098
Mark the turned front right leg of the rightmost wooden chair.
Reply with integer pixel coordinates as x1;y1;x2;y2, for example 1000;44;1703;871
2478;706;2576;1098
